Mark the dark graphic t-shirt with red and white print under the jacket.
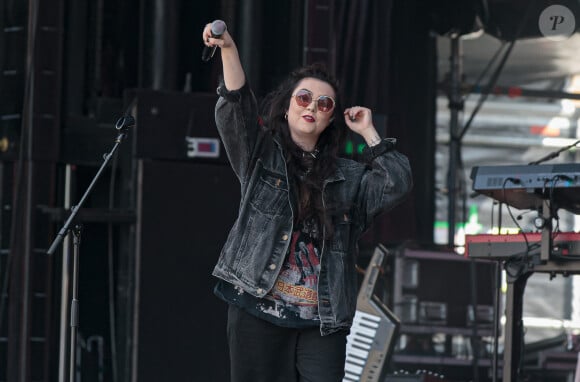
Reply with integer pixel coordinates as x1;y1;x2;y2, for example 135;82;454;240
215;230;320;328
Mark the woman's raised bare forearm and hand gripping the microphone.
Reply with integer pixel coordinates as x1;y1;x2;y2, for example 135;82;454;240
203;23;246;90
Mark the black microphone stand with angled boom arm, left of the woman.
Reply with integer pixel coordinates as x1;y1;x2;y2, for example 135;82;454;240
46;115;135;382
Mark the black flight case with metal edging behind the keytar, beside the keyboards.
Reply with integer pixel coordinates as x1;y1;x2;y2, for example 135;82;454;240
394;246;497;334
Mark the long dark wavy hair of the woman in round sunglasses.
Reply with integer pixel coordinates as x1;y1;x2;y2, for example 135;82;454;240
262;63;345;239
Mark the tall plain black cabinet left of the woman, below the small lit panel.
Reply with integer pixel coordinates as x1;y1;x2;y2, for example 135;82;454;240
132;159;239;382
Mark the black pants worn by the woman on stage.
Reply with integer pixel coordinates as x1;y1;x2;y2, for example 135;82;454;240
227;305;348;382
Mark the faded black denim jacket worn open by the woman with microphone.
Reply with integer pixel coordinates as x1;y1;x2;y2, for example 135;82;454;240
213;83;412;335
